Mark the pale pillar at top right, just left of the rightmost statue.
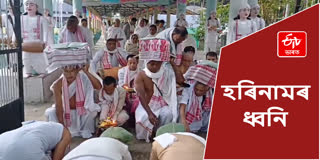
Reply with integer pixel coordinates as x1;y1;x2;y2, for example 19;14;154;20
227;0;248;44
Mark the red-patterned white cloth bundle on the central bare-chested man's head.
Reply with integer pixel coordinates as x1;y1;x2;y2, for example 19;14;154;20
139;38;170;62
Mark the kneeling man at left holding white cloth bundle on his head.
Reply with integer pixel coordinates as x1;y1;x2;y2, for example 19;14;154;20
45;44;102;138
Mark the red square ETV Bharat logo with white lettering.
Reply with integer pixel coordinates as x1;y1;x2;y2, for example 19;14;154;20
278;31;307;58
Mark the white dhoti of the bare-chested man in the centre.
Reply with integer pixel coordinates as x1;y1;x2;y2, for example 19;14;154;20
136;103;173;142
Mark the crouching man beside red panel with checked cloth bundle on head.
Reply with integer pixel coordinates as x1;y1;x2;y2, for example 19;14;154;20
179;62;216;132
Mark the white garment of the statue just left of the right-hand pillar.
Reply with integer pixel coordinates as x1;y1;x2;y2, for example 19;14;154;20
206;19;220;52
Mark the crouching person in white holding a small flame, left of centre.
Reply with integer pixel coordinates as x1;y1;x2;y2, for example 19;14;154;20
99;76;129;126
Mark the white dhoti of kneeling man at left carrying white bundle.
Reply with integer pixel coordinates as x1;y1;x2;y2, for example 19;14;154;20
45;105;97;138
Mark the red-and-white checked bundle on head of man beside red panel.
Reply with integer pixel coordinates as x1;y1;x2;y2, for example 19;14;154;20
184;65;217;88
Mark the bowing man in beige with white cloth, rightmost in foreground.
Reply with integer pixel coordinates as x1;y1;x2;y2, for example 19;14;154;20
150;132;206;160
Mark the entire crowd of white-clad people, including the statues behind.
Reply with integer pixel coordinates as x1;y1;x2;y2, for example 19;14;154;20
0;0;264;160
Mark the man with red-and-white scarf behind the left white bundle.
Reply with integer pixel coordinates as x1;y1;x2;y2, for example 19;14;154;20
91;38;128;72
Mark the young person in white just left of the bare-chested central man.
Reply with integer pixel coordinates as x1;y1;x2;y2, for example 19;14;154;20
118;55;139;113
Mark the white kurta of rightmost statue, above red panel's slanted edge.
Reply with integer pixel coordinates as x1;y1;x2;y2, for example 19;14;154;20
229;19;257;42
